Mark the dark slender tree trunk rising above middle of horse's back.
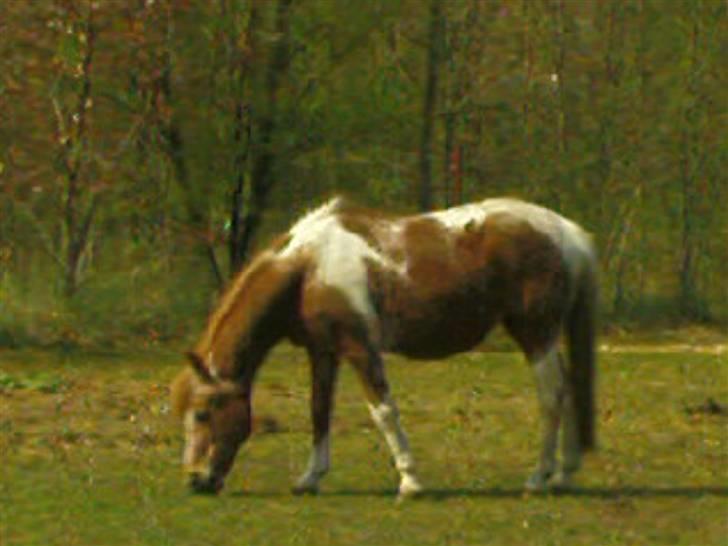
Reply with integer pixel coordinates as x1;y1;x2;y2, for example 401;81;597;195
419;0;443;211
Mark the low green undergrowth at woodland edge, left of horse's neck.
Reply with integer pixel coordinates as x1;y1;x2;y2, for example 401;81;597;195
0;240;214;351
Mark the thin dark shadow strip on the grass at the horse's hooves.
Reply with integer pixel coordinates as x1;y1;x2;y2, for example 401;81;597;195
228;486;728;501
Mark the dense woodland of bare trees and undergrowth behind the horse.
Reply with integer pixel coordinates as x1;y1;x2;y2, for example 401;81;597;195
0;0;728;347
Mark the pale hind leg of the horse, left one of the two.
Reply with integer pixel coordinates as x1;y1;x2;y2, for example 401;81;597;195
526;348;565;491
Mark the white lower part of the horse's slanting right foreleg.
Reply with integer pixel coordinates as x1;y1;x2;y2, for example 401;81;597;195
369;396;422;497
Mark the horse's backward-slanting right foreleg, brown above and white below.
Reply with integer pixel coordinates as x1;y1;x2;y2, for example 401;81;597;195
351;351;422;498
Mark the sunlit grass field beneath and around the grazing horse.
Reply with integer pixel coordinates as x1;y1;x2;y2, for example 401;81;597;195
0;338;728;546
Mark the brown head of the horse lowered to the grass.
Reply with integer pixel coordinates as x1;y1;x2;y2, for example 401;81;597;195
172;353;251;493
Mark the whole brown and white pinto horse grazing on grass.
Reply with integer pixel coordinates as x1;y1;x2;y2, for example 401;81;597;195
172;198;596;496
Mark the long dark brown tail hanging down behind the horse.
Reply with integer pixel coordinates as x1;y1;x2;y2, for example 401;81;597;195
566;248;597;451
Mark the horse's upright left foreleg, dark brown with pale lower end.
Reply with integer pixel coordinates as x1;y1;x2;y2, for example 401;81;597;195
293;353;338;494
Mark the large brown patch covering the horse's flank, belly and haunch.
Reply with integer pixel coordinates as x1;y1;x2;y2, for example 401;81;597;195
368;213;567;358
